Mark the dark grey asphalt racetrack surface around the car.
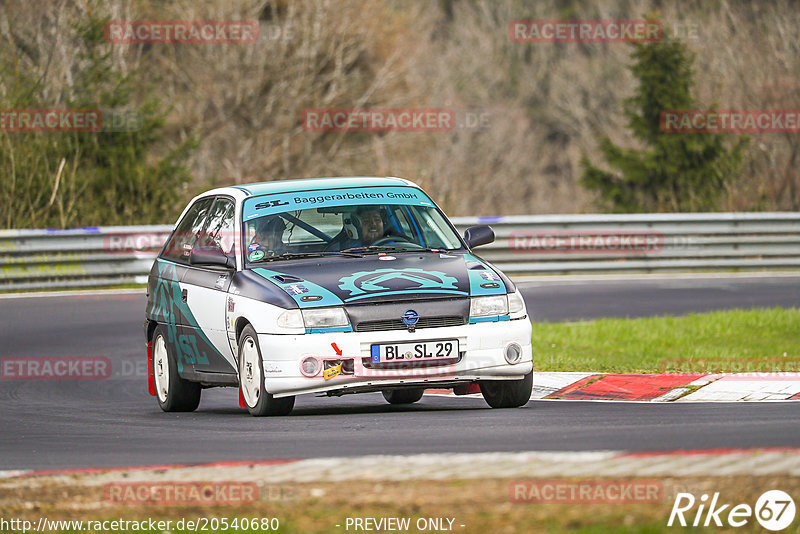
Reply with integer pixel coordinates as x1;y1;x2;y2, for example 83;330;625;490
0;276;800;470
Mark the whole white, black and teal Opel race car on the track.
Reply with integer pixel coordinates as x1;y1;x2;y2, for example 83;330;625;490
144;177;532;415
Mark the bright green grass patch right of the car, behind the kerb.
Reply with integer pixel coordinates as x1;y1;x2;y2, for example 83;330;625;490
533;308;800;373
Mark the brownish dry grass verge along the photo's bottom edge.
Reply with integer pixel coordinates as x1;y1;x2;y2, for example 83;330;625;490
0;476;800;534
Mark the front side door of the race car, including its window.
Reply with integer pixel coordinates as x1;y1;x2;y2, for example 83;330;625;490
181;196;236;382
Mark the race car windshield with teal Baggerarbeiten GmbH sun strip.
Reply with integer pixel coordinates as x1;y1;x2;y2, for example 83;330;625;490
242;187;462;263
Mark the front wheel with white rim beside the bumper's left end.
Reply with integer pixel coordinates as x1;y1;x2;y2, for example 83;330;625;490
238;325;294;417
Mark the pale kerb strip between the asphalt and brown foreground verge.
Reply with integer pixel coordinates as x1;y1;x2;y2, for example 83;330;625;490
3;449;800;486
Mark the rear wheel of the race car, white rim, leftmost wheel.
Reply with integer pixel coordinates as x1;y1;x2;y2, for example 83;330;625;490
153;325;202;412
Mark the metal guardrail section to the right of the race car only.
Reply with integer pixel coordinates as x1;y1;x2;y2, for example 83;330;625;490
454;212;800;274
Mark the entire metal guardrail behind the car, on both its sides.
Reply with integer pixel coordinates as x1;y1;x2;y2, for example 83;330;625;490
0;212;800;291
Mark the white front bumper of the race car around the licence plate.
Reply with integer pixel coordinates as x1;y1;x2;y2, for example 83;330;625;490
258;318;533;397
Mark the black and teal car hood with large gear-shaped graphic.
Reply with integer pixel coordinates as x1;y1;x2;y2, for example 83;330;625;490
241;252;513;308
